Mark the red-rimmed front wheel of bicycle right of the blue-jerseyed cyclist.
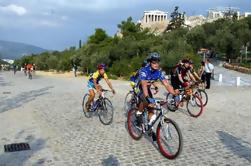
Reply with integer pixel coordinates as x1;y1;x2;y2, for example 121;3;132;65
187;94;203;118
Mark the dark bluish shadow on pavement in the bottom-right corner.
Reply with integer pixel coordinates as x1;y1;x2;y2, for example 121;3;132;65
217;131;251;163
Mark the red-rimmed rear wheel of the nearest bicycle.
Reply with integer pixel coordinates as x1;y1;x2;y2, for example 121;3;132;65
127;108;143;140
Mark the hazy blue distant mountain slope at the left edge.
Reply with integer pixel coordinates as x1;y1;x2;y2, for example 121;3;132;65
0;40;47;59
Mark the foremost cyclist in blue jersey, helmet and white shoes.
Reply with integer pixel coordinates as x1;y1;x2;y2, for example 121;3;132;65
136;52;176;140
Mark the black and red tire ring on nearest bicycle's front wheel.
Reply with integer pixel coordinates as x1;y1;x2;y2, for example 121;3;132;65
157;118;183;159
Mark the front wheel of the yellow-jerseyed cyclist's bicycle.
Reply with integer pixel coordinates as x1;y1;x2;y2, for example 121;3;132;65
98;98;114;125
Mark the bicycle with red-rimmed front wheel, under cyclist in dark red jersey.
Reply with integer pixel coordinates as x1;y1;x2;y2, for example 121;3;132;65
166;84;204;118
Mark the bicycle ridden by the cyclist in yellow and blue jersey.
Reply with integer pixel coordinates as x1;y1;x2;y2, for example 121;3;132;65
82;89;114;125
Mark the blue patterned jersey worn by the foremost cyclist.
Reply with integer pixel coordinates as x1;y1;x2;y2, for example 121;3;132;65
139;65;165;82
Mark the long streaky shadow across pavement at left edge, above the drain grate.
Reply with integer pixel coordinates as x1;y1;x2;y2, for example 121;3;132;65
0;86;54;113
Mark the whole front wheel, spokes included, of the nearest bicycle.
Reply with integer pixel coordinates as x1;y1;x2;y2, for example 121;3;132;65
157;118;183;159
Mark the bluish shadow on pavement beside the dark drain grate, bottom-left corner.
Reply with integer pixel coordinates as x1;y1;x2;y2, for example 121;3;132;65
0;138;46;166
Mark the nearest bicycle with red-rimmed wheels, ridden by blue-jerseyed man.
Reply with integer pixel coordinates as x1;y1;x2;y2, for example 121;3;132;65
127;100;183;159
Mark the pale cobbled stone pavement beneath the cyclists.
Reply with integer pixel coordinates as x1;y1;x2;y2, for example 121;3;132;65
0;72;251;166
